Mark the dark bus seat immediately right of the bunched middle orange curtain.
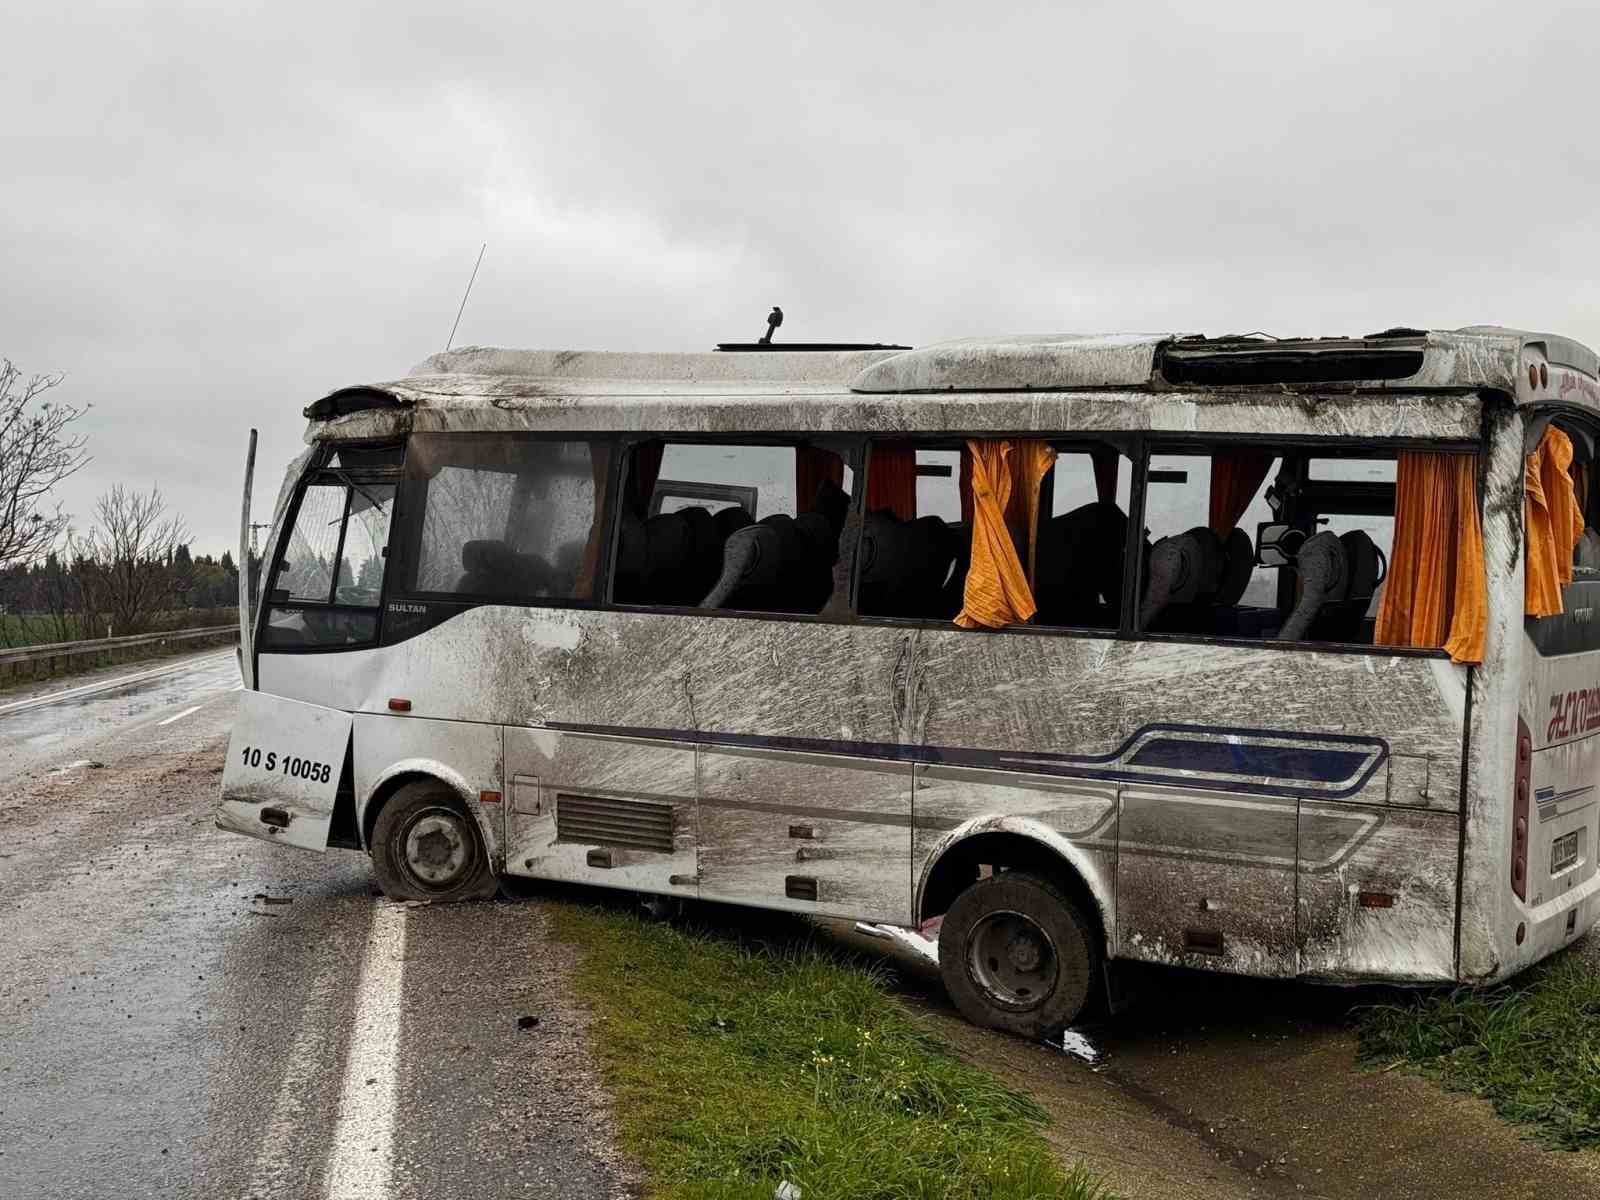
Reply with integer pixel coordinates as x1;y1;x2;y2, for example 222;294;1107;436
1034;501;1128;626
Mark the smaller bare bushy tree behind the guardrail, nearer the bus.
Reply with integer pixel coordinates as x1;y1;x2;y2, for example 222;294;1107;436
78;483;189;634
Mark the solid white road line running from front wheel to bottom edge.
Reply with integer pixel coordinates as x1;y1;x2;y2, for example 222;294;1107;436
323;902;406;1200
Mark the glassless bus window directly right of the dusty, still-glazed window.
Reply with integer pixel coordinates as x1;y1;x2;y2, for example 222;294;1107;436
613;442;853;613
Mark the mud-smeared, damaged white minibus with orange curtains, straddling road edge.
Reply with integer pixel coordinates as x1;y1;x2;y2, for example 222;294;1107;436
218;328;1600;1035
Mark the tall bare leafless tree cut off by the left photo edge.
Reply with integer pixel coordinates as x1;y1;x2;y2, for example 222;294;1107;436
0;358;88;566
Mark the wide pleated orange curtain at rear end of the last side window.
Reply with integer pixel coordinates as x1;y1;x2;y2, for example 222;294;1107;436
1373;451;1488;662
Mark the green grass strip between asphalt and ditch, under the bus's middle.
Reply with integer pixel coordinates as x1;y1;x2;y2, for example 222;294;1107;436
557;906;1110;1200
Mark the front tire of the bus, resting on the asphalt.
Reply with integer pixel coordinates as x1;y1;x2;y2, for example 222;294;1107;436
371;779;498;902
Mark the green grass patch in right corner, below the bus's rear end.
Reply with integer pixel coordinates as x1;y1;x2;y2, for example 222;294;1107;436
1358;954;1600;1149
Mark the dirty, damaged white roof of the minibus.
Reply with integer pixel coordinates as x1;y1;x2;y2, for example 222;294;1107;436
306;326;1600;440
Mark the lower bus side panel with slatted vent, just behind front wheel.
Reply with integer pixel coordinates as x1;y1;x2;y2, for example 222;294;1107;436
504;726;696;896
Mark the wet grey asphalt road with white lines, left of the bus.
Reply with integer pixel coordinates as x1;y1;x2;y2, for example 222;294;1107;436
0;653;627;1198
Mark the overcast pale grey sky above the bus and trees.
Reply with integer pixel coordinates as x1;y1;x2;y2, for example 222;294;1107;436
0;0;1600;554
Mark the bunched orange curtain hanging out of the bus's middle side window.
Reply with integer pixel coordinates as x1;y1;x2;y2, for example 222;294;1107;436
955;438;1056;629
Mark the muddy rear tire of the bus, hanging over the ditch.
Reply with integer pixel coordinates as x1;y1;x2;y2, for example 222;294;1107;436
939;870;1101;1038
